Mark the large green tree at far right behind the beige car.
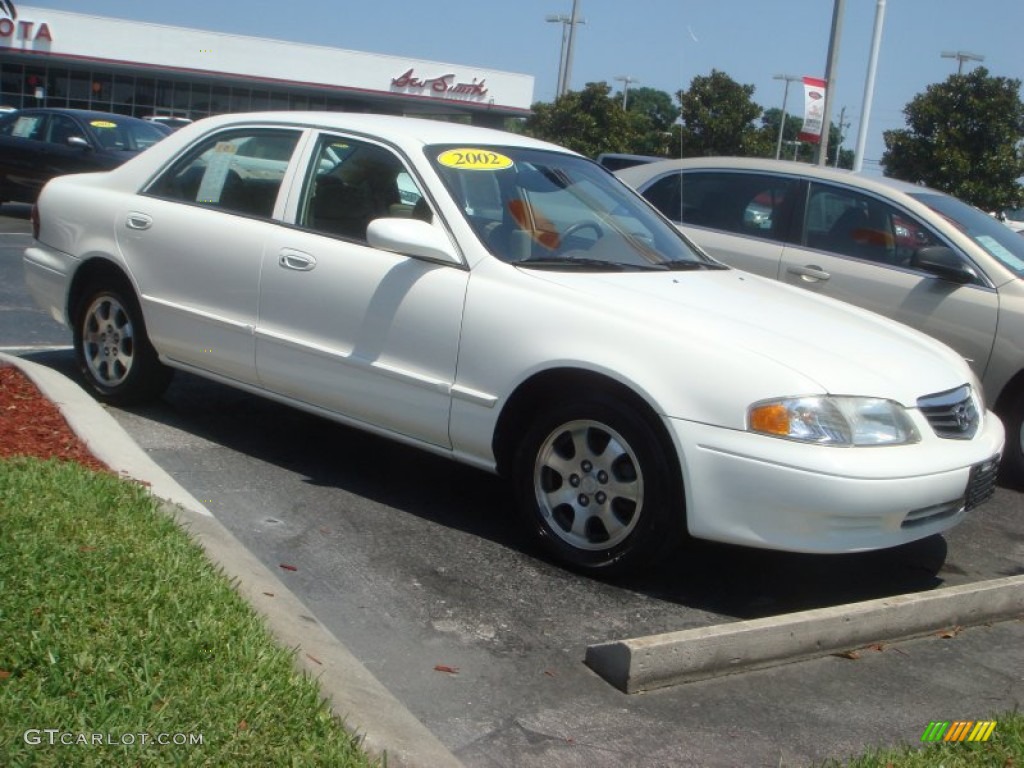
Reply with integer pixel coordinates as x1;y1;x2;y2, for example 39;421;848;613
882;67;1024;211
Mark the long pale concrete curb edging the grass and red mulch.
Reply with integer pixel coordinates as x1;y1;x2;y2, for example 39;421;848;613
0;352;462;768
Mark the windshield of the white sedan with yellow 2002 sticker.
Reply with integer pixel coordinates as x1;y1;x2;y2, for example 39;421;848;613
426;146;722;270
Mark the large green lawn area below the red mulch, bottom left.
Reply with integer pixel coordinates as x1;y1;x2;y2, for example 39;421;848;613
0;459;373;766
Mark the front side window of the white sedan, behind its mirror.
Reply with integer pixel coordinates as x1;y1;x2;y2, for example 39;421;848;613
298;136;433;243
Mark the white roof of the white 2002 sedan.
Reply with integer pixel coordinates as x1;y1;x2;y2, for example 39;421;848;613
169;111;569;153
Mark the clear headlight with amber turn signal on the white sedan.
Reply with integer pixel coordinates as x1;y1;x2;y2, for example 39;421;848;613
748;396;921;445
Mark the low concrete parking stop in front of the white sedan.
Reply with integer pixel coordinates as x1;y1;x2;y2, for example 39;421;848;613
586;575;1024;693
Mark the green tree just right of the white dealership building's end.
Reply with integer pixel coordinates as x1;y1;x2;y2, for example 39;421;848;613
524;83;639;158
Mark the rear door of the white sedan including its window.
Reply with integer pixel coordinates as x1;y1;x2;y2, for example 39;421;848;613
116;127;302;391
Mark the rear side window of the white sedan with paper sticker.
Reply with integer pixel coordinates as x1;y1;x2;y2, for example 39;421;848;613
146;129;301;218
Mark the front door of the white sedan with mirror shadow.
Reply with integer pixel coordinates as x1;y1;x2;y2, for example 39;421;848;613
256;134;469;446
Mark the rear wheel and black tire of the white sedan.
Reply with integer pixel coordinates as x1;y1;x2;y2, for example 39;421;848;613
74;279;173;406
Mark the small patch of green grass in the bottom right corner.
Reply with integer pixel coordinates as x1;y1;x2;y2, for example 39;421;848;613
823;711;1024;768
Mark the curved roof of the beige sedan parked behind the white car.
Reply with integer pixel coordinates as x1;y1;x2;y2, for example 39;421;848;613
615;157;945;201
